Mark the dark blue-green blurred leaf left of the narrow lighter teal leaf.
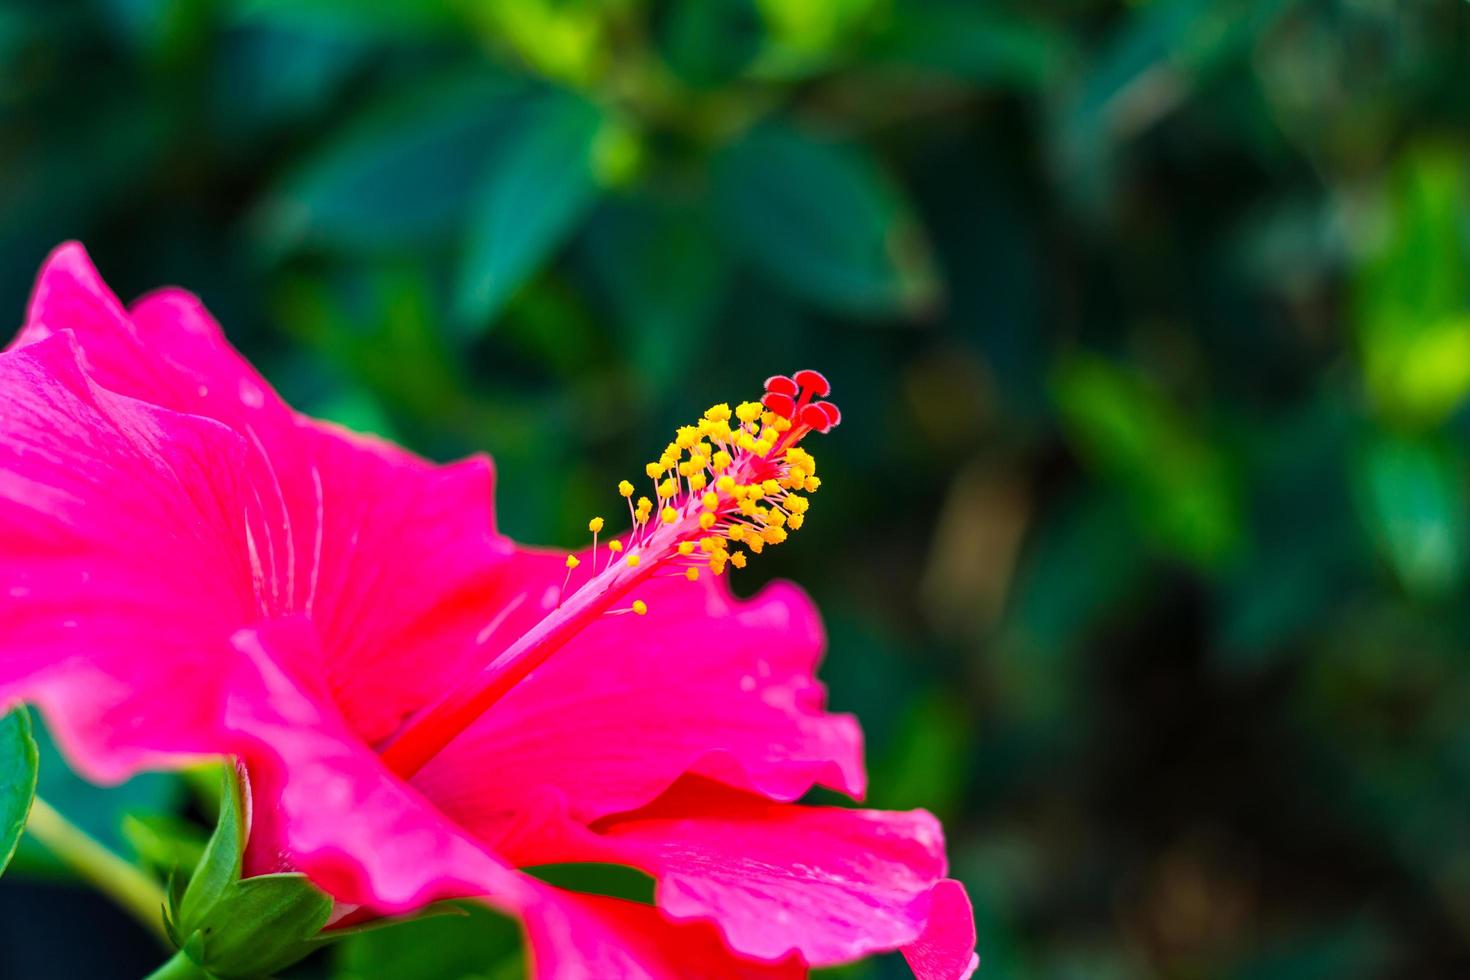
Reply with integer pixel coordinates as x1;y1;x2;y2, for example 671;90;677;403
257;73;528;251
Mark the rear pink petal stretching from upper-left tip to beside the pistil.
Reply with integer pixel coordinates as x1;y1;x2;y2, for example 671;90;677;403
16;242;510;739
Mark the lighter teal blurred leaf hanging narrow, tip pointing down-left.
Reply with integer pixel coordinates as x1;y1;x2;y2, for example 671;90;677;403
456;94;604;332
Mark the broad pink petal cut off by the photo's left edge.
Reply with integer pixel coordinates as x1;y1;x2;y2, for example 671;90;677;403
0;334;256;780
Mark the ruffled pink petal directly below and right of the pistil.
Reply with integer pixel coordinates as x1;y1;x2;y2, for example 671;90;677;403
413;564;864;840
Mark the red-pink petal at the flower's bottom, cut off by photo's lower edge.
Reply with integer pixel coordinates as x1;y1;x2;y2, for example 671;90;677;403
522;887;807;980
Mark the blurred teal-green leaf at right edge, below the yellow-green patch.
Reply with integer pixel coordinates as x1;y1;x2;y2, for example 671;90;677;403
1357;436;1470;598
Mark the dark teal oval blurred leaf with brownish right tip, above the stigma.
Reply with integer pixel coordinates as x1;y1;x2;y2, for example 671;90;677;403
714;123;938;316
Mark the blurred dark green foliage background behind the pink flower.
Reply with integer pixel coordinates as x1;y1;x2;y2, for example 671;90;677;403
0;0;1470;980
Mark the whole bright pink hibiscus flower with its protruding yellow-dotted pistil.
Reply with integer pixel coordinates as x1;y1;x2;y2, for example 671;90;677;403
0;244;978;977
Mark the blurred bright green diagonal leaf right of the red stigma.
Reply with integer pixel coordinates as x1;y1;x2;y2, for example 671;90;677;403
1054;356;1241;566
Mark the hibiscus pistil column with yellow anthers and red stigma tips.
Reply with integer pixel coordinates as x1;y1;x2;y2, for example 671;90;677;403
382;370;842;779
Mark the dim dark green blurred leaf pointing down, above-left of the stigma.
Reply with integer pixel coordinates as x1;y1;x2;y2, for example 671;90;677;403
587;195;729;386
